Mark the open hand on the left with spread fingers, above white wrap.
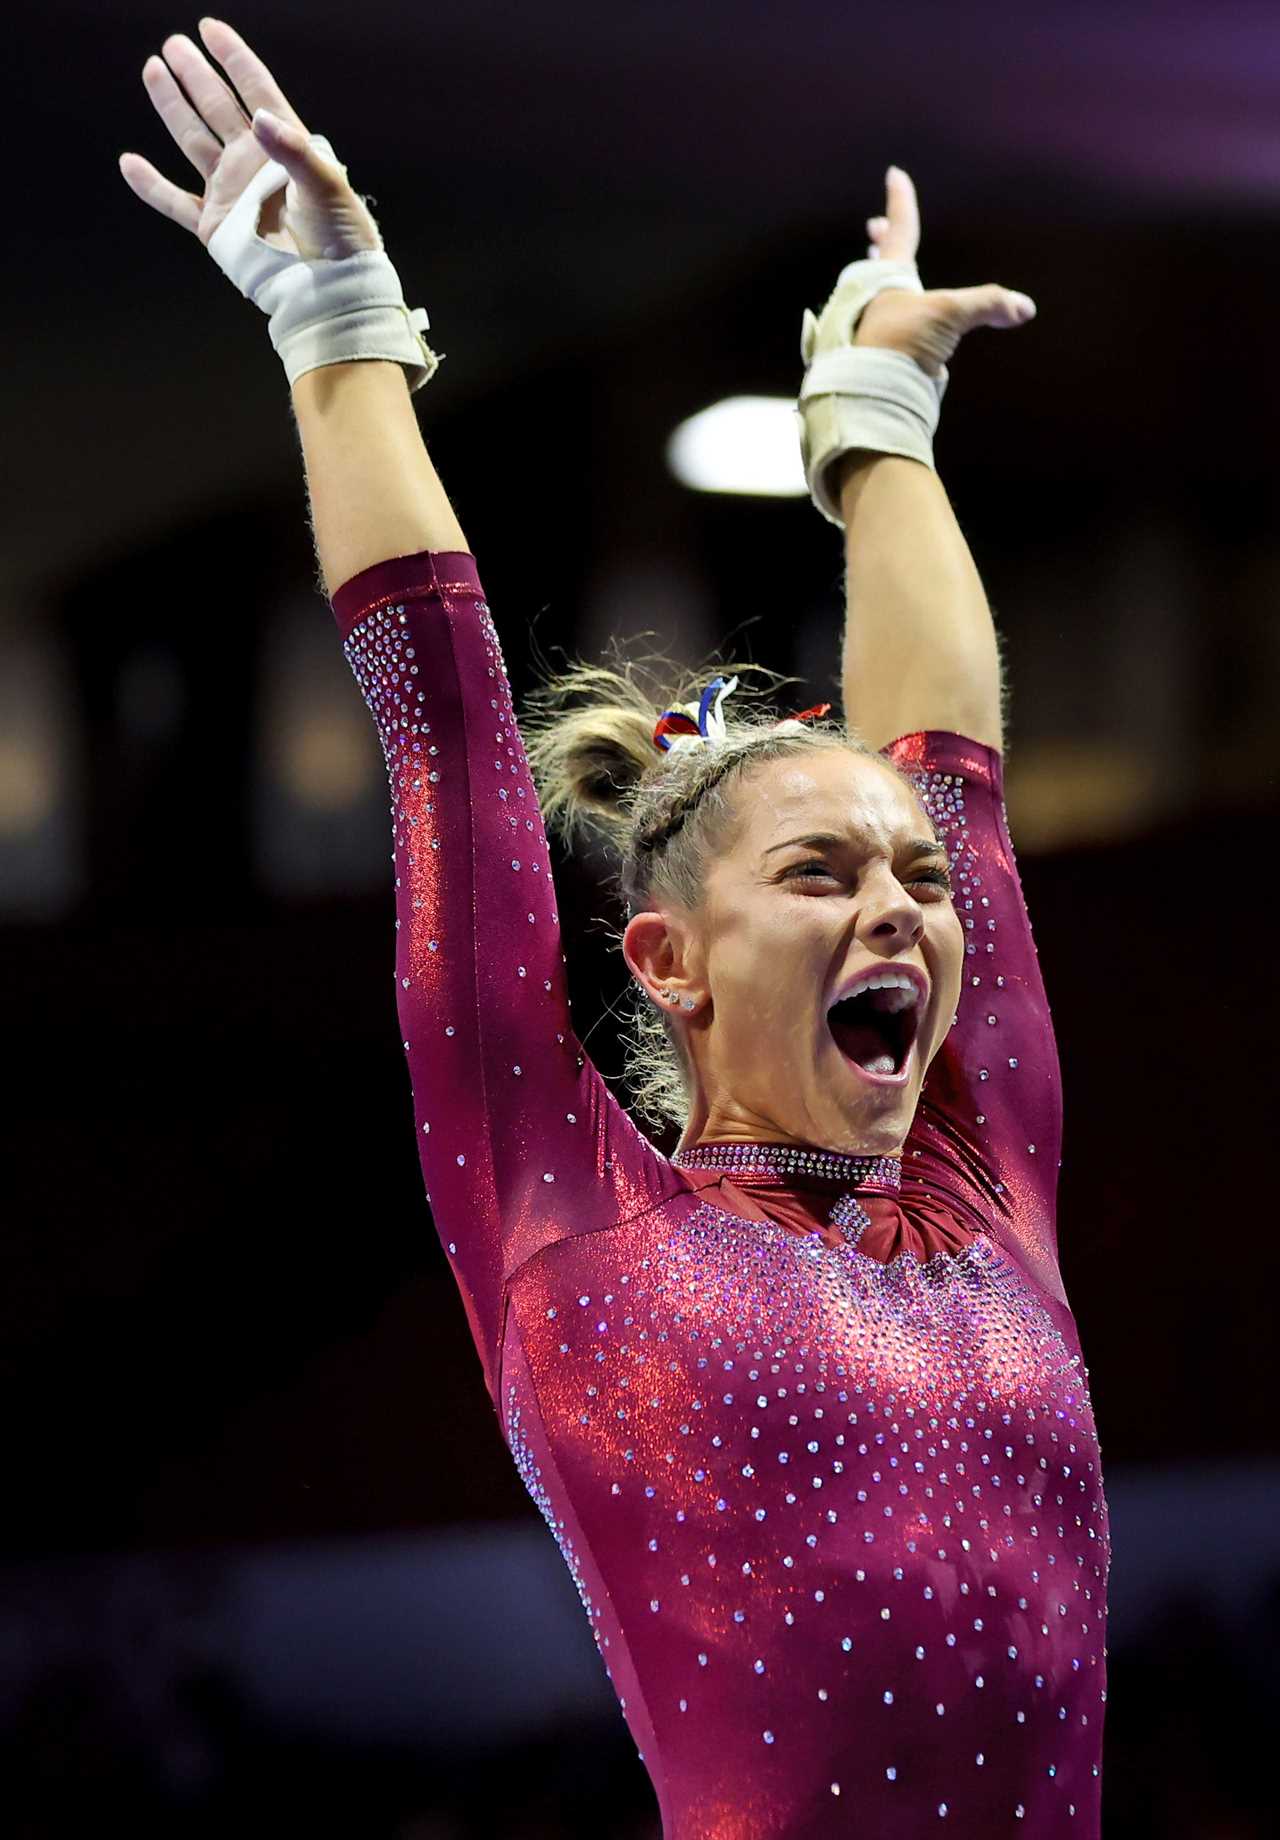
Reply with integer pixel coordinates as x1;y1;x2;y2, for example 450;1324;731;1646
120;18;383;261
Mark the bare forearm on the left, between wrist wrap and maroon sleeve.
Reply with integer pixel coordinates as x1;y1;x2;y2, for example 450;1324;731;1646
292;361;467;596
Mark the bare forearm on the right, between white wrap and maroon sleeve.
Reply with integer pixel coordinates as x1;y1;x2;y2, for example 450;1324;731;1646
840;453;1002;749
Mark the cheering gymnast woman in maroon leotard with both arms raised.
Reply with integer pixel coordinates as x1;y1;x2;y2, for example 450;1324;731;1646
121;20;1109;1840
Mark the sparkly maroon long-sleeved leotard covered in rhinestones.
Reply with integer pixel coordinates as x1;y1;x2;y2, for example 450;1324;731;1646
333;554;1111;1840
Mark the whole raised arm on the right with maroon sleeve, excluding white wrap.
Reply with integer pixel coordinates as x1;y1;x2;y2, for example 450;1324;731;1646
801;167;1061;1297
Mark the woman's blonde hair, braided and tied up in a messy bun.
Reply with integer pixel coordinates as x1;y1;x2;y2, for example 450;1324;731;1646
520;640;916;1128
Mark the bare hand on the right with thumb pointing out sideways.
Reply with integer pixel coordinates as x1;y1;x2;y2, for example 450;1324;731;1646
853;166;1035;377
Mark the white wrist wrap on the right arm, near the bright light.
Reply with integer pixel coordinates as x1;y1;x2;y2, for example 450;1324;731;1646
796;258;949;526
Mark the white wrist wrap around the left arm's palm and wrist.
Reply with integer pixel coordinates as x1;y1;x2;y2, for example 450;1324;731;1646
208;134;443;392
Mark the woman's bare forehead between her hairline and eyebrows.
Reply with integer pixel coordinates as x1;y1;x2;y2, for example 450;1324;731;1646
739;747;932;850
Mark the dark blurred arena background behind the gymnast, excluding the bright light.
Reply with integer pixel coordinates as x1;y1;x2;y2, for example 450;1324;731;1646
0;0;1280;1840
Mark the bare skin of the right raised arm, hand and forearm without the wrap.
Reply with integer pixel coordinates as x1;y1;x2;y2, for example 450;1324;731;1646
840;167;1035;751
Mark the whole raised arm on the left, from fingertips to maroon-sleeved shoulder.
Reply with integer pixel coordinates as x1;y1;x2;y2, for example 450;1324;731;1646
121;20;682;1406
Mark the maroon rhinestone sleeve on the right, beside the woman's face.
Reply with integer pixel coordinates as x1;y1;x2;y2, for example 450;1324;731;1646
883;729;1065;1303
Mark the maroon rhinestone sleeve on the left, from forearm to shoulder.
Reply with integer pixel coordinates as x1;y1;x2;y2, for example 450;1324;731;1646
333;552;679;1402
